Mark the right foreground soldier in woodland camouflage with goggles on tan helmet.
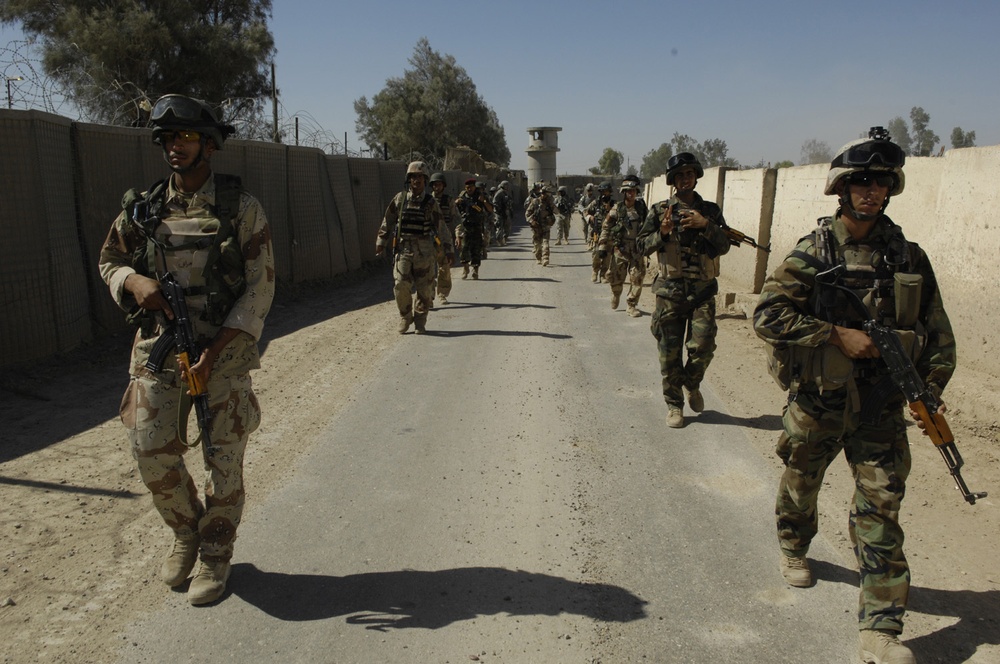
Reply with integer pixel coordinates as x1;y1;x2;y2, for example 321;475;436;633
754;127;956;664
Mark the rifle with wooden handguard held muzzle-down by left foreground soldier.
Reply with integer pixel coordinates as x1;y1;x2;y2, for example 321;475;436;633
146;272;216;456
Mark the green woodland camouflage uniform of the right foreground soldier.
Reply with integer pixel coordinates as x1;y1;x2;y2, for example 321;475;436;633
754;215;956;633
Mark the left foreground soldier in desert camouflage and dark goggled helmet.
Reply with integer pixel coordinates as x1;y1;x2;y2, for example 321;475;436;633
100;94;274;604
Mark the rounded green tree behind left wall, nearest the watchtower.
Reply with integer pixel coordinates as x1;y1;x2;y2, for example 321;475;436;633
354;37;510;166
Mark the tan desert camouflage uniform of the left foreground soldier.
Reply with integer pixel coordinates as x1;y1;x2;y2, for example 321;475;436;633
100;177;274;561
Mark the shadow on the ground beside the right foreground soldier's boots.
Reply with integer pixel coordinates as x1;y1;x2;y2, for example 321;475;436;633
809;560;1000;662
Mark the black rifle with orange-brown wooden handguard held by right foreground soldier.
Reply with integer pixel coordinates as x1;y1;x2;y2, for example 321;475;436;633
816;265;986;505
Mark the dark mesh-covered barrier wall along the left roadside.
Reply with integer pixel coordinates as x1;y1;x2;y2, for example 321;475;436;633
0;109;478;367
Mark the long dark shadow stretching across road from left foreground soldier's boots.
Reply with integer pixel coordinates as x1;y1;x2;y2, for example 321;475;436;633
229;563;646;631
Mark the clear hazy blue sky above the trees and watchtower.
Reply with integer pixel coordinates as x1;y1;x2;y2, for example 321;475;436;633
0;0;1000;174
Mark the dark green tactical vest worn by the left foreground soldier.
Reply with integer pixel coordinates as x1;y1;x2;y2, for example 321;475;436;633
122;173;246;338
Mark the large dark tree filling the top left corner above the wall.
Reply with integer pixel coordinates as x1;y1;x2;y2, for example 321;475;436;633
0;0;275;125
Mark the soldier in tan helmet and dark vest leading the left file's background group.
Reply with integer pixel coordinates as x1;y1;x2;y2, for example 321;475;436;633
375;161;455;334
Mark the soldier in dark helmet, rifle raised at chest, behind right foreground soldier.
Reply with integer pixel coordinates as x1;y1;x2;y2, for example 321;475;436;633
636;152;730;429
